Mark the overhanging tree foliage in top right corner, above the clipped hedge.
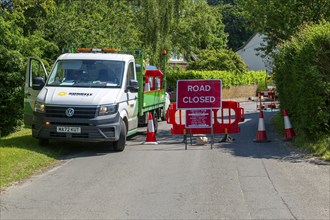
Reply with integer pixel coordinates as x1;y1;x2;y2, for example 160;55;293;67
237;0;330;53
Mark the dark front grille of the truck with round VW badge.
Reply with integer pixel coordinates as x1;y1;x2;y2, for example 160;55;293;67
46;106;97;118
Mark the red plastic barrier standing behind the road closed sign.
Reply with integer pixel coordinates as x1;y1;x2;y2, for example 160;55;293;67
166;101;244;135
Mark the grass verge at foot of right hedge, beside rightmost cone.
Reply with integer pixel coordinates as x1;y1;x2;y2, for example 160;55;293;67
273;113;330;161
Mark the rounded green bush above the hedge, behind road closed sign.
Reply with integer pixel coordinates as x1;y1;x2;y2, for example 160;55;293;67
188;49;248;74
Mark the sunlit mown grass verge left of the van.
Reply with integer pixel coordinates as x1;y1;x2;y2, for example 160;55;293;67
0;128;87;189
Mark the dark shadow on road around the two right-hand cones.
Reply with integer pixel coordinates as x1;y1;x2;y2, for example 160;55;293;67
216;112;330;165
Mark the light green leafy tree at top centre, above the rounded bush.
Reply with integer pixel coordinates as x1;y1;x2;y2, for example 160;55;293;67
172;0;227;58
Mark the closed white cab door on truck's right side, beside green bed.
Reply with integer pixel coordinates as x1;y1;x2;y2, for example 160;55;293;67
126;61;138;130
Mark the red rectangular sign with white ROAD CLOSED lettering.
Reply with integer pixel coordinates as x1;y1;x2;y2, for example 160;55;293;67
176;80;222;109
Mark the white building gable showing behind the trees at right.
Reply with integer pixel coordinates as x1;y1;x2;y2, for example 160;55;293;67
236;34;272;73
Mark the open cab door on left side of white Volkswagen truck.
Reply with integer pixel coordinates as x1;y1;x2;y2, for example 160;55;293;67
24;57;48;127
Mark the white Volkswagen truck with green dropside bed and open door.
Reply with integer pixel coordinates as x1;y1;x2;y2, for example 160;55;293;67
24;48;169;151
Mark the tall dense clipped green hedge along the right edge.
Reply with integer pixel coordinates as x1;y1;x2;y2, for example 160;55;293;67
275;21;330;140
